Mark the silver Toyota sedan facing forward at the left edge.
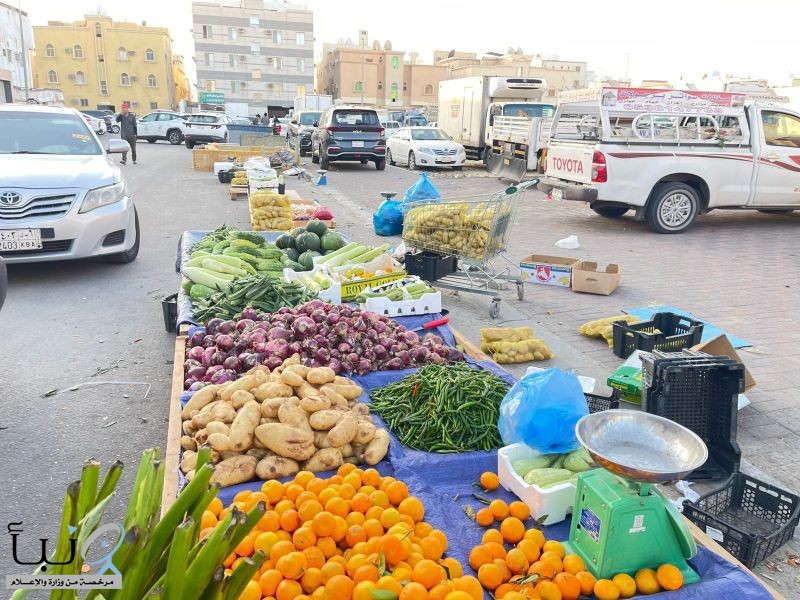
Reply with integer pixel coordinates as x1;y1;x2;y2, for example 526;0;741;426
0;104;139;263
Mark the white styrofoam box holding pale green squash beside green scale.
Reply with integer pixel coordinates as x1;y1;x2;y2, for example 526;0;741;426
497;444;577;525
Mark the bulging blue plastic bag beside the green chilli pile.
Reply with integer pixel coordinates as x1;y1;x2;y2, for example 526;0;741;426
497;369;589;454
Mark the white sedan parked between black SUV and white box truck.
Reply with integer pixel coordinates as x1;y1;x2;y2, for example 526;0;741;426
386;127;467;171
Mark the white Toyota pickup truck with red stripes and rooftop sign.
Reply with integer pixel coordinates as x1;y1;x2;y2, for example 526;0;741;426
539;88;800;233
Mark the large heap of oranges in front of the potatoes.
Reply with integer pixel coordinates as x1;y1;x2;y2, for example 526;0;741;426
200;463;483;600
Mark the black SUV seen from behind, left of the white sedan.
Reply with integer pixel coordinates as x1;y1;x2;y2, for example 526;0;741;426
311;106;386;171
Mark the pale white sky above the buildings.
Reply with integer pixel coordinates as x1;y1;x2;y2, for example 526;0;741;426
18;0;800;85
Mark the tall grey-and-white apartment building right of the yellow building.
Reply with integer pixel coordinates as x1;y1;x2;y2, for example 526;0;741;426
192;0;314;115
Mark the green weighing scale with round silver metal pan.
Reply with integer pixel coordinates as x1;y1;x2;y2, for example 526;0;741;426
565;410;708;584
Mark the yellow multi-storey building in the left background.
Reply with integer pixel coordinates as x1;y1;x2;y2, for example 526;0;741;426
33;15;177;114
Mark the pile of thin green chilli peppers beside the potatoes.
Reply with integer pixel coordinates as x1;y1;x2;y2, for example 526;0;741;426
370;363;509;453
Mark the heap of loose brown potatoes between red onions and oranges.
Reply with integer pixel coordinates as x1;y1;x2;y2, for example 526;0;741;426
181;355;389;487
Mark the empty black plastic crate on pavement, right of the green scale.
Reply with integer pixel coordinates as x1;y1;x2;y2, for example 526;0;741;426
683;473;800;569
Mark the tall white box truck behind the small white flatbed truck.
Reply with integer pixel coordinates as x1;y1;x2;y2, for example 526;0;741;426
438;75;552;166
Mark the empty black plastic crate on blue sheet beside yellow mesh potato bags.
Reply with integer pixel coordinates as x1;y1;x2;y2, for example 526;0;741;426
613;313;703;358
